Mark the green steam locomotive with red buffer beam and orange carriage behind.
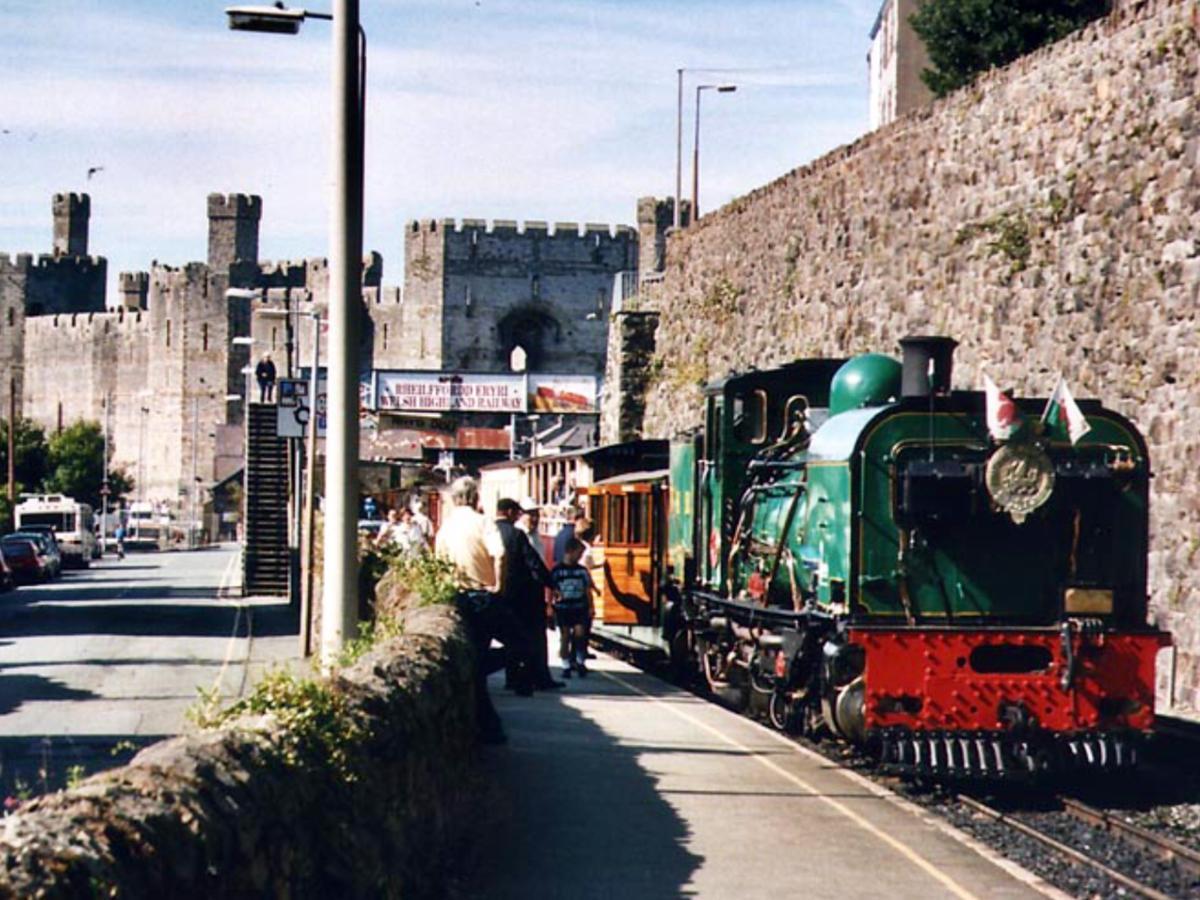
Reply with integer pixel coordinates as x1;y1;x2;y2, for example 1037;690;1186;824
581;336;1170;779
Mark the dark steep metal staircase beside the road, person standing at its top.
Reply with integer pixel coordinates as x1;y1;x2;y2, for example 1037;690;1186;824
241;403;290;596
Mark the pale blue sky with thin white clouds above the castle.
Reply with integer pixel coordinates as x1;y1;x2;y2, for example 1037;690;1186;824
0;0;880;294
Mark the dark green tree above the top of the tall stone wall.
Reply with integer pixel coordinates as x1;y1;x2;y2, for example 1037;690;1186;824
910;0;1110;97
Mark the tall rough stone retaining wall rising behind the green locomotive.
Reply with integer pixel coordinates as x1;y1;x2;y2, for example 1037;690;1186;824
642;0;1200;709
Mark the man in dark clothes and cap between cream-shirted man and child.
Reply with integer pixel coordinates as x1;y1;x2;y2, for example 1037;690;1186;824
496;497;563;690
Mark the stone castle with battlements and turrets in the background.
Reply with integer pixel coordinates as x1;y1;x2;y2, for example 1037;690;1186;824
0;193;654;520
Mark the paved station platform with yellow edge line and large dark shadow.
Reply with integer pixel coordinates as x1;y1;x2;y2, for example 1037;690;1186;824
464;654;1064;900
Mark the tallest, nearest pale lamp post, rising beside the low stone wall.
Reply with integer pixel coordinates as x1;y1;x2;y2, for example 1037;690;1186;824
226;0;367;666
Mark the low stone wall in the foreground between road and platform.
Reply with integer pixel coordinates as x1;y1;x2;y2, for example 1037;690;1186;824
0;607;478;900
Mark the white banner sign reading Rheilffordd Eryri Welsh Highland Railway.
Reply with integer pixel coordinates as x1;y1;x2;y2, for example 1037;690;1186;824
376;372;526;413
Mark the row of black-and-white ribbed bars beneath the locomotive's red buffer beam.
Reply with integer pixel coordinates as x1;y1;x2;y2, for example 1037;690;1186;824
869;728;1138;779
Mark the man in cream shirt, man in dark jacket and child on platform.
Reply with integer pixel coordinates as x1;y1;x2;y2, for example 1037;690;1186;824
434;476;595;743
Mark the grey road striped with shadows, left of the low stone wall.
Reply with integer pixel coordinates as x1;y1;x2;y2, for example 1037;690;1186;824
0;546;298;796
